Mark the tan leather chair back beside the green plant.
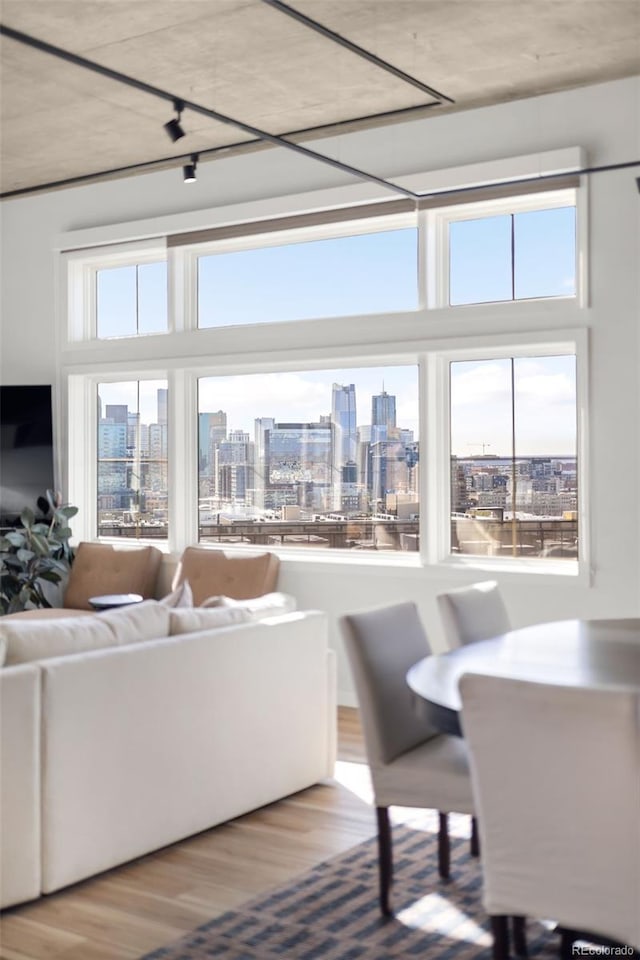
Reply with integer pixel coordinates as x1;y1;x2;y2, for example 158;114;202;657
64;542;162;610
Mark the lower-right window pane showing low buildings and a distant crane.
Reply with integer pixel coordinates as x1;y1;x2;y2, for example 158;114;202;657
450;355;579;560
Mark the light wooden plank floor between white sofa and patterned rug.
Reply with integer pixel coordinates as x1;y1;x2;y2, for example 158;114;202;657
0;707;375;960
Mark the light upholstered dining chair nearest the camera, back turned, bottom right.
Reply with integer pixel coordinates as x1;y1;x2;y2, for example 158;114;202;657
460;674;640;960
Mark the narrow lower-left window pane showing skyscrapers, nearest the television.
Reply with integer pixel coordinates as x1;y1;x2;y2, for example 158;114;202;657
97;380;168;538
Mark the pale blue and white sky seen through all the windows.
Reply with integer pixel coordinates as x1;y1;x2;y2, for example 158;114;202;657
97;207;576;456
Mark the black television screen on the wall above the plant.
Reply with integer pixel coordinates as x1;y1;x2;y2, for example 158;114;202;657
0;385;54;527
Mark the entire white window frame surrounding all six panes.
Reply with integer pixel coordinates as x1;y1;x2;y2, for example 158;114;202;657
58;158;590;582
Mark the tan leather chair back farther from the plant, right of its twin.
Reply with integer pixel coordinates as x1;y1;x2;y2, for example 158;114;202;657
172;547;280;606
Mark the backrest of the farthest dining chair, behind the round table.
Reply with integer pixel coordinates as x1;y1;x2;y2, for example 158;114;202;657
436;580;511;649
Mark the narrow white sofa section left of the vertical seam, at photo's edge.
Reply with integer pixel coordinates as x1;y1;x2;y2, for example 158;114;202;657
0;663;40;908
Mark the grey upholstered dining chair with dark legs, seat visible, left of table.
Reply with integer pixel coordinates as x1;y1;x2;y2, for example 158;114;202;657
341;603;476;916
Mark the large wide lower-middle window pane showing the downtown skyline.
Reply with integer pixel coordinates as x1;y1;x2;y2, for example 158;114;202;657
198;366;420;550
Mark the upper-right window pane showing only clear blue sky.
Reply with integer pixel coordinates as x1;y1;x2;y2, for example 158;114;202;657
448;195;576;306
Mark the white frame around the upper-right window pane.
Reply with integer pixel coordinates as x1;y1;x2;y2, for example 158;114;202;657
427;187;587;311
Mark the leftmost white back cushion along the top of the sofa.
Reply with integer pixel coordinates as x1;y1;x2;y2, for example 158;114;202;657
0;614;117;665
